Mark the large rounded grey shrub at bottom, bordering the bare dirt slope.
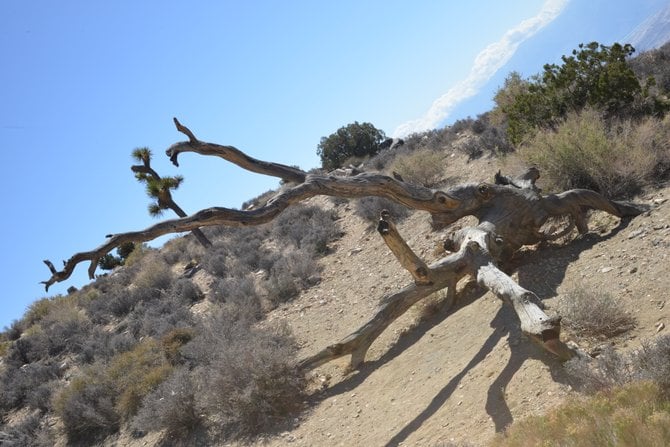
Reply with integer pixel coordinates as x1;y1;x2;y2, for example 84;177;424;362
184;313;306;437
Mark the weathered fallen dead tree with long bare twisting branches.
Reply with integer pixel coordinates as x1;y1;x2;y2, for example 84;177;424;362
43;118;647;370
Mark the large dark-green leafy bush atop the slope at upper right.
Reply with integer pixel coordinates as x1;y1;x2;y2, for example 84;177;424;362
494;42;669;145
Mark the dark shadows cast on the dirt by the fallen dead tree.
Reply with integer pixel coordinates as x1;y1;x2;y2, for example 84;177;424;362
310;219;630;446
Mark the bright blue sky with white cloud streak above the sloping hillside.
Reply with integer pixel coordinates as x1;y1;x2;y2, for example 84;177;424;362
0;0;666;328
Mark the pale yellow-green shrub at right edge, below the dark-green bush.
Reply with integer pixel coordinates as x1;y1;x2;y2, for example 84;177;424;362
520;109;670;197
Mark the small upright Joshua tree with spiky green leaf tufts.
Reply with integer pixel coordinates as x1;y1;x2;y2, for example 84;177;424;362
130;147;212;248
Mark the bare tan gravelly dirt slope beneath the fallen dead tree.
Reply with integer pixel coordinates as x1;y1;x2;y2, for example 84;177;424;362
245;151;670;446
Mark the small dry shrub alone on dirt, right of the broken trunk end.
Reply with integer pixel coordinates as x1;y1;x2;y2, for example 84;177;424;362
559;287;635;338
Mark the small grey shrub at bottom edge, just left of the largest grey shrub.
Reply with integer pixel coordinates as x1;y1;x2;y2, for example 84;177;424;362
132;368;205;445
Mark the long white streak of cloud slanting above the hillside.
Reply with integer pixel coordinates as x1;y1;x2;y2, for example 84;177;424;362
393;0;569;137
